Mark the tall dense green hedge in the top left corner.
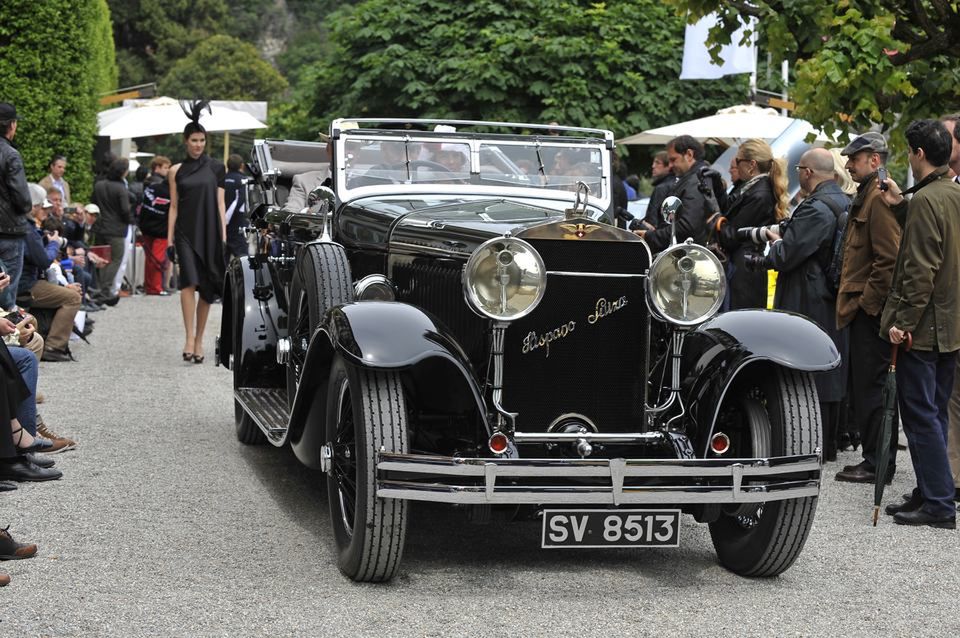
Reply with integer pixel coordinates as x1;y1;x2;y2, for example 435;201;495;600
0;0;117;201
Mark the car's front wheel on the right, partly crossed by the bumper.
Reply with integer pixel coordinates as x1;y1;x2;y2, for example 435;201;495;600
710;367;820;577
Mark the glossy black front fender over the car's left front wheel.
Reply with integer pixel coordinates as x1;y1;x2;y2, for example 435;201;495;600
289;301;492;467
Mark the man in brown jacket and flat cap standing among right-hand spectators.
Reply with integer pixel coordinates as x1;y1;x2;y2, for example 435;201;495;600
836;132;900;483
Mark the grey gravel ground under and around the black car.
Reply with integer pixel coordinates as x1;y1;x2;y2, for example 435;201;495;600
0;296;960;638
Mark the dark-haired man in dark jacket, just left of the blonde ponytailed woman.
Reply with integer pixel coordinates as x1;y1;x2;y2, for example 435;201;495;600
635;135;719;253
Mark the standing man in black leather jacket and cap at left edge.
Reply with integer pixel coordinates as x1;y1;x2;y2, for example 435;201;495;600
0;102;33;309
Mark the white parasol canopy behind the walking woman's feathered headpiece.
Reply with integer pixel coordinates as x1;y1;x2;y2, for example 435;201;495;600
97;97;267;140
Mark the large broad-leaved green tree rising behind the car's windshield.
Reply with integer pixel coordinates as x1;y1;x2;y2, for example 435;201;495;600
283;0;747;141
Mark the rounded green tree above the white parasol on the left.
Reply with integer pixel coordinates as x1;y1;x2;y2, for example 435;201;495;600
158;35;287;100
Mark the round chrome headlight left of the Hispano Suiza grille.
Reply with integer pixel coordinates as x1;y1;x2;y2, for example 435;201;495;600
463;237;547;321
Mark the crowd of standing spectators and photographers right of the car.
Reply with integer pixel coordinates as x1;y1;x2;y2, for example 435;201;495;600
631;115;960;529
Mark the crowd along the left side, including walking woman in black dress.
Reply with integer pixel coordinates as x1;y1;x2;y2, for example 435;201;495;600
0;102;240;586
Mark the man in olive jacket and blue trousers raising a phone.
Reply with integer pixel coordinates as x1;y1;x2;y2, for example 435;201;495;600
880;120;960;529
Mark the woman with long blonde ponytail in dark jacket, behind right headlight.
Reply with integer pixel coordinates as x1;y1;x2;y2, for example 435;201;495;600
718;139;787;310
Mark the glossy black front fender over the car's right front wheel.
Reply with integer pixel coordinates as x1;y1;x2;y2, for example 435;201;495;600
681;310;840;453
